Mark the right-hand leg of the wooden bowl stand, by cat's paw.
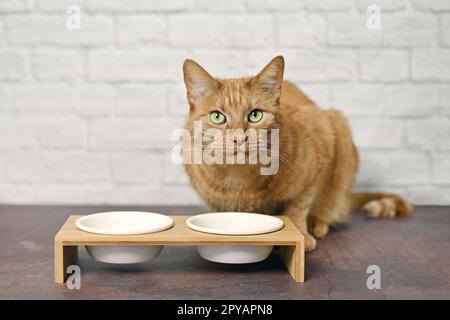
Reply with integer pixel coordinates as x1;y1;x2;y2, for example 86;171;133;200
280;239;305;282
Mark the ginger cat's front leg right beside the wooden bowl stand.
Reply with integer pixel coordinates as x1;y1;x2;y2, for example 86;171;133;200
285;195;316;252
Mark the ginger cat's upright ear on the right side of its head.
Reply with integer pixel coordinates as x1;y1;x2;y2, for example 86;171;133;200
256;56;284;98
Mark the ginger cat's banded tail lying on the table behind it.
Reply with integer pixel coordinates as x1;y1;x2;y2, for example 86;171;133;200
351;192;413;218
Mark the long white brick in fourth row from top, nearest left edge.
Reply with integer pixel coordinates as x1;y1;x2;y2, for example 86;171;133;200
14;85;115;116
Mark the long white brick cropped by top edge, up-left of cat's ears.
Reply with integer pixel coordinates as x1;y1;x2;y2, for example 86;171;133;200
87;0;190;13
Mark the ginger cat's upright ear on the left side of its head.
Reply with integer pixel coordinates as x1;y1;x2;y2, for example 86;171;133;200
183;59;218;108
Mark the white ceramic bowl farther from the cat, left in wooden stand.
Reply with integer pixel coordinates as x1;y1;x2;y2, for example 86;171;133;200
75;211;173;264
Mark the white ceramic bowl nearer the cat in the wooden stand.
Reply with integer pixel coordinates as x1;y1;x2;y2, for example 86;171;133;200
186;212;284;264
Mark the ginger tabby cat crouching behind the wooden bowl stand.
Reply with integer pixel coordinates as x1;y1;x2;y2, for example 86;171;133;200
183;56;412;251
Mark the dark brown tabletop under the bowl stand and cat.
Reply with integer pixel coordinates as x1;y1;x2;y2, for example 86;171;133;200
0;206;450;299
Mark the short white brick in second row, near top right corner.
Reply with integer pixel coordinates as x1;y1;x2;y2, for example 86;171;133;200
381;14;438;47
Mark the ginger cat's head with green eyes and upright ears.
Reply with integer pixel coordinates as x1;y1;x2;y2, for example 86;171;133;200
183;56;284;157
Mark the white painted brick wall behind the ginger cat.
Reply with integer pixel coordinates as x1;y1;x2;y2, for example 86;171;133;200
0;0;450;205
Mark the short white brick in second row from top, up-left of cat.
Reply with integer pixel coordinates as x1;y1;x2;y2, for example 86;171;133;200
117;15;166;46
